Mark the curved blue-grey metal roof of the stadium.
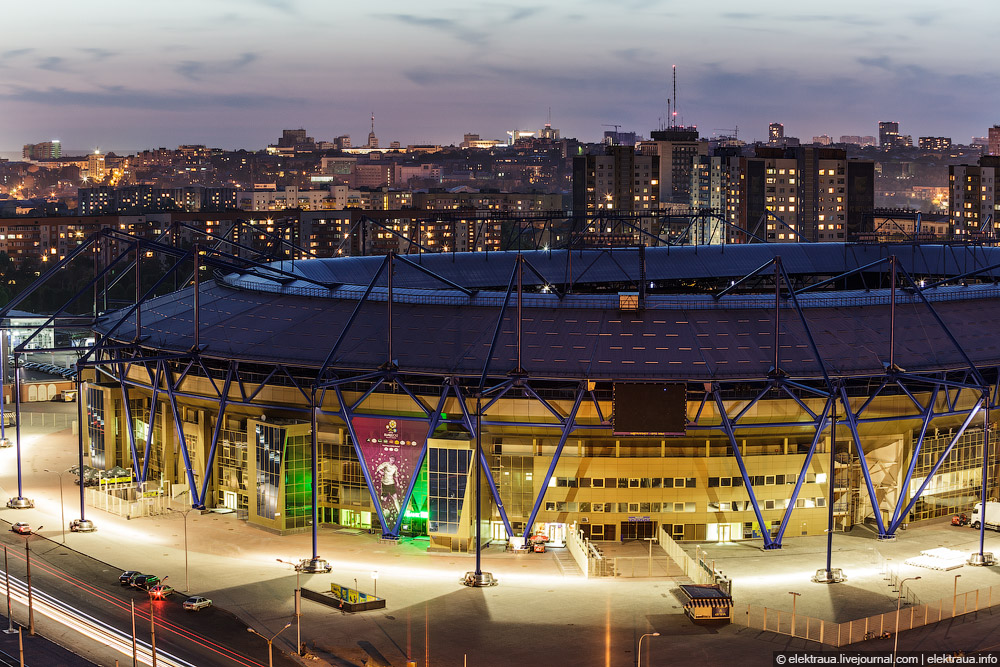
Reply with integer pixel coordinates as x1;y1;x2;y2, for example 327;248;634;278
99;244;1000;381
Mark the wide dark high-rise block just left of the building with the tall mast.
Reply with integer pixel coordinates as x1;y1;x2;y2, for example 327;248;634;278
573;146;662;213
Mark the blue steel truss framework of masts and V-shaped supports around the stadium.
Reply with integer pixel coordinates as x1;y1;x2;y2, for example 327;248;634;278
0;230;1000;558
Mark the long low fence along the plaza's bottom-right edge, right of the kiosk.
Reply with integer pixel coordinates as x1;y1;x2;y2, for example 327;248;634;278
733;586;1000;647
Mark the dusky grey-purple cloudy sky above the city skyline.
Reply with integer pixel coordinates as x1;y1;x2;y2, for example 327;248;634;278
0;0;1000;152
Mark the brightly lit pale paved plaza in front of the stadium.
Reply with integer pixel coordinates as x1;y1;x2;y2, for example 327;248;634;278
0;404;1000;667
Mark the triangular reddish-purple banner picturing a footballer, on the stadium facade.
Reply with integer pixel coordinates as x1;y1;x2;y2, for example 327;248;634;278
351;417;427;527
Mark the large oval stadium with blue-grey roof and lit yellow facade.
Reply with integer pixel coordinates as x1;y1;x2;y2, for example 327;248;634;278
25;243;1000;557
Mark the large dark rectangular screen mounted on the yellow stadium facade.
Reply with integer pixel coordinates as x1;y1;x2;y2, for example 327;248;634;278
611;382;687;435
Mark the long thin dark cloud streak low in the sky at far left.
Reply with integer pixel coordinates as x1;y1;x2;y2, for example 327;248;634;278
0;86;305;111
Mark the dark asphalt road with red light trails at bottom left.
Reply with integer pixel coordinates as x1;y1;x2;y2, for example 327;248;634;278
0;522;296;667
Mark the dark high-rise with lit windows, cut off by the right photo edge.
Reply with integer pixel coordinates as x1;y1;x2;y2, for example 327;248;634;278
948;155;1000;237
